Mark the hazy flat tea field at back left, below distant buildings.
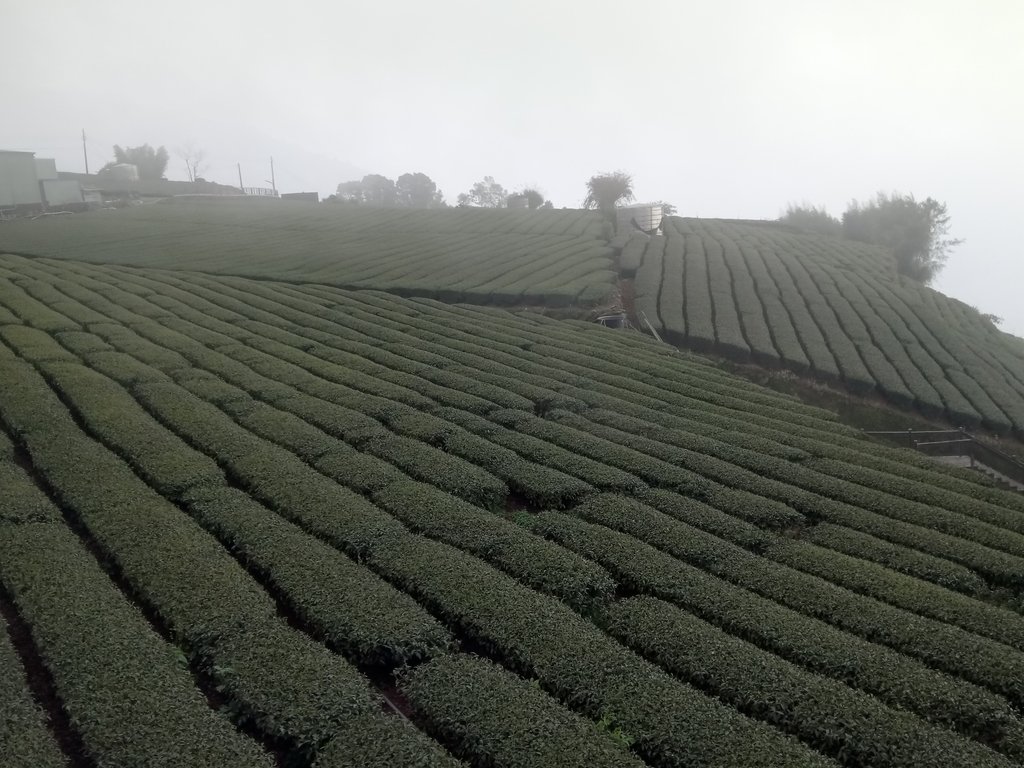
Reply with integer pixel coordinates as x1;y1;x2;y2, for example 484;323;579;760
0;199;615;306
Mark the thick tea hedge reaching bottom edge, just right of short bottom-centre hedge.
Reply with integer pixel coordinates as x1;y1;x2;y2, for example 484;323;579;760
372;540;828;766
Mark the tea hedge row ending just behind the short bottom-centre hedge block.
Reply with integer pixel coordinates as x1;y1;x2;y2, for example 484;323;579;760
17;335;449;665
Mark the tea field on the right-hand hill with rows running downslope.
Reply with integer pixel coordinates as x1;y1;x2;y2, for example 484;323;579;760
634;217;1024;435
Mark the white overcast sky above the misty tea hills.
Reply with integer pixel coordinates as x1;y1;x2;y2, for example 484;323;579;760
0;0;1024;335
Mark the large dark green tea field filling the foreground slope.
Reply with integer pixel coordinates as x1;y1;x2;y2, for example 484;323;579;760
0;249;1024;768
